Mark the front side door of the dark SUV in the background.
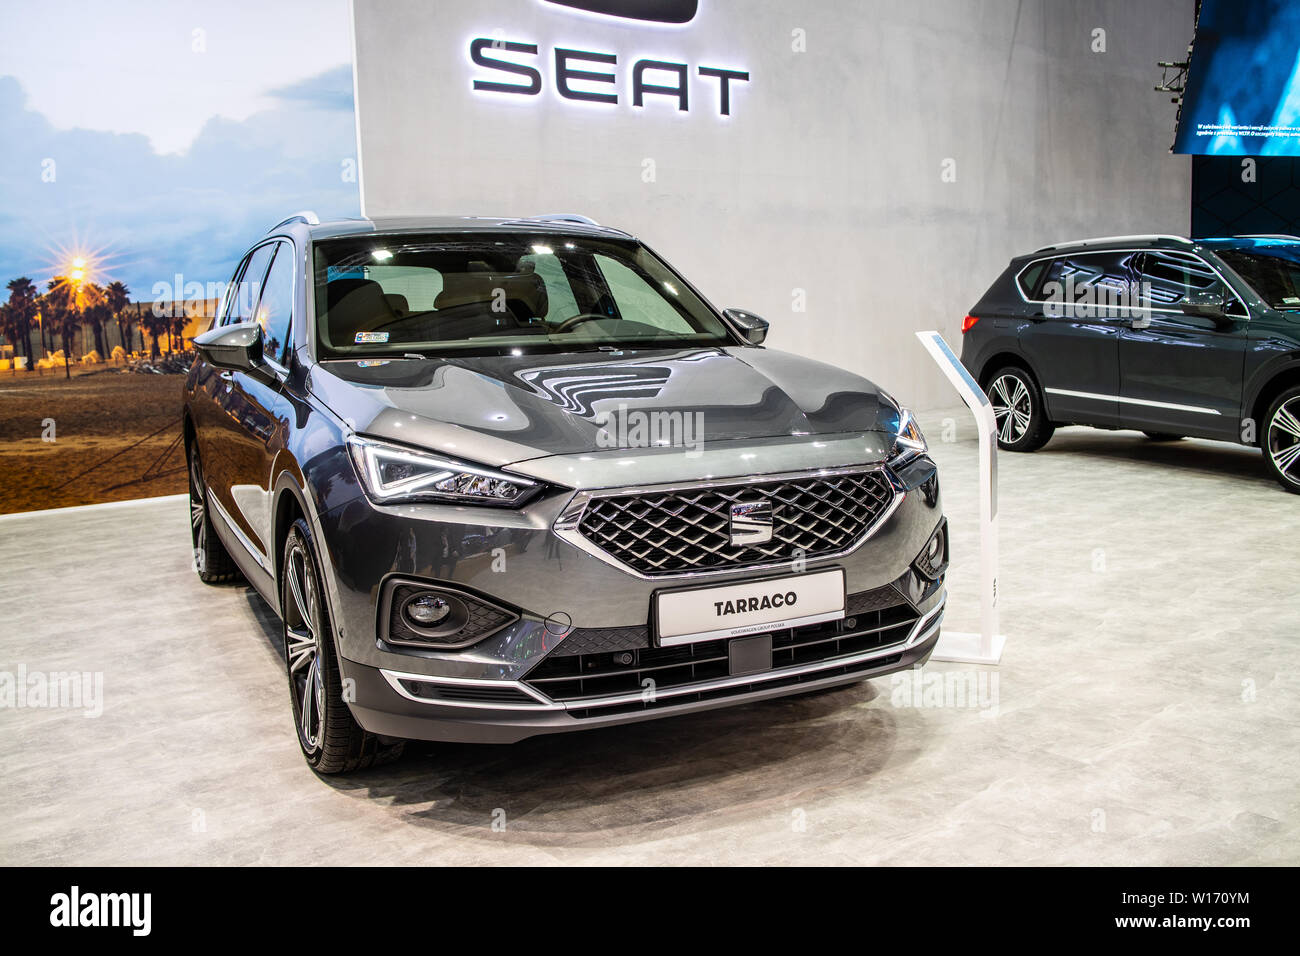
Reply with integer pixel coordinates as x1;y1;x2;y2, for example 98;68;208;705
1119;251;1249;440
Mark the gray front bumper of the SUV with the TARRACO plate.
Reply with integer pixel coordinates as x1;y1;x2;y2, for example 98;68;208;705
317;459;945;743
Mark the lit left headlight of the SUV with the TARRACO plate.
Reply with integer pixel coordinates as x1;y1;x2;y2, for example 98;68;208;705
347;436;538;507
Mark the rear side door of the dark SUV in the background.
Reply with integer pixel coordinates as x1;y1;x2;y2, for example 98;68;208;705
1021;251;1132;425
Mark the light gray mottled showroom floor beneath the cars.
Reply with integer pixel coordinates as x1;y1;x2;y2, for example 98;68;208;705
0;410;1300;865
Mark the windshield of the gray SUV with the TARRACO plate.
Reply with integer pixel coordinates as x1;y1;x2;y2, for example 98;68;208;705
315;233;733;359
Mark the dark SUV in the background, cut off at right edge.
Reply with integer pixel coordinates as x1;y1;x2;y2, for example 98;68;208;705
962;235;1300;493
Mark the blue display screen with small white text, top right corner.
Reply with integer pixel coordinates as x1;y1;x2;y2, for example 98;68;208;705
1174;0;1300;156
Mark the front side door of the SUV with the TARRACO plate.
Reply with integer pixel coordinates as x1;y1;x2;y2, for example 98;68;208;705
228;239;296;572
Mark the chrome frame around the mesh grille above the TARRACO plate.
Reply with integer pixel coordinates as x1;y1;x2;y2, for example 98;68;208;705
551;463;907;581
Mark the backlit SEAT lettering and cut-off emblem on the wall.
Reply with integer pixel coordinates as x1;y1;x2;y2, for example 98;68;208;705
469;0;749;116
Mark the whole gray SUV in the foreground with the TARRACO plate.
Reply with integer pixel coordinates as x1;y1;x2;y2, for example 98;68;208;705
185;213;948;773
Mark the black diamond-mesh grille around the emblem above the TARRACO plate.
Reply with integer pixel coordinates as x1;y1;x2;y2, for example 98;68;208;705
577;471;894;575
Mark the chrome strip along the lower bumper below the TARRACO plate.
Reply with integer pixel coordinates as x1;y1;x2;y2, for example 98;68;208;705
380;591;948;713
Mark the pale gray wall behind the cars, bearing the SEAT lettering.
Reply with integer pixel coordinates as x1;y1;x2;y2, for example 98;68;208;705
354;0;1192;408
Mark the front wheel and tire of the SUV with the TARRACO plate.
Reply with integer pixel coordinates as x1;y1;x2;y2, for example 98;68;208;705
280;518;404;774
